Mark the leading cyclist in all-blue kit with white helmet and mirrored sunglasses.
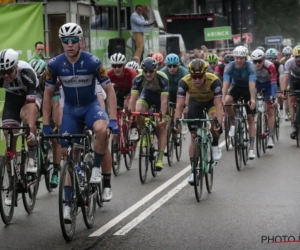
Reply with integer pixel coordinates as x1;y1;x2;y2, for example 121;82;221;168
43;23;119;221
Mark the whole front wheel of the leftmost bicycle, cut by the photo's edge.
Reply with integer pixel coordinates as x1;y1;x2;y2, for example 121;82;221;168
0;155;16;225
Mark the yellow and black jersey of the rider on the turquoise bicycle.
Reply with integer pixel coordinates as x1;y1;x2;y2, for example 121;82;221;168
177;73;222;102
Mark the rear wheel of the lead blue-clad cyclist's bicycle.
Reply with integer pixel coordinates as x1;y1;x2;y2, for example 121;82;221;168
81;162;98;229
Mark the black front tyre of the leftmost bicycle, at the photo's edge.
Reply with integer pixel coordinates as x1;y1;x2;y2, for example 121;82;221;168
0;154;16;225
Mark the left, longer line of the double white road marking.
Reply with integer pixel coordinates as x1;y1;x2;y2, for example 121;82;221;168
89;141;225;237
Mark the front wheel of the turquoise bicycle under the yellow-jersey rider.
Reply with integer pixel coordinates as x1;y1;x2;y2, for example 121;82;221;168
193;137;203;202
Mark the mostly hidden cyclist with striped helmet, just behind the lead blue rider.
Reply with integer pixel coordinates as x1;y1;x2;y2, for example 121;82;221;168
29;59;61;188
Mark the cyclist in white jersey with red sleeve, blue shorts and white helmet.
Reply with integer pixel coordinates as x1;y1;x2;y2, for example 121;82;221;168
251;49;277;148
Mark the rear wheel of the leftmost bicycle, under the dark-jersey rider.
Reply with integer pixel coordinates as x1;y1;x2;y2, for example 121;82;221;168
21;151;39;214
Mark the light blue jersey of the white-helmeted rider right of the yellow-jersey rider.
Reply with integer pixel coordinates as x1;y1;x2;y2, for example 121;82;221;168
223;61;256;87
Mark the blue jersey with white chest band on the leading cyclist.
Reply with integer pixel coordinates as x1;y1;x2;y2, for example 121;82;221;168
46;51;111;106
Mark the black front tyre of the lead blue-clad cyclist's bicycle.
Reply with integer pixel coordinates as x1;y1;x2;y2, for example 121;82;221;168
58;161;78;242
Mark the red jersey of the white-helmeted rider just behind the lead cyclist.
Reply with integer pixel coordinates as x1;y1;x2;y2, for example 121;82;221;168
107;68;137;91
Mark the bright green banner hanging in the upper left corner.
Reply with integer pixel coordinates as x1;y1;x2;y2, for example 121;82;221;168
0;3;44;61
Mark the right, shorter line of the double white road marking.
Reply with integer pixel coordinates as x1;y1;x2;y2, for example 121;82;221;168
114;142;225;235
